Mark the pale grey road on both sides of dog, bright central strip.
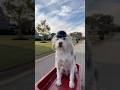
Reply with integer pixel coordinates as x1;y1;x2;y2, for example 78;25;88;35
35;41;85;82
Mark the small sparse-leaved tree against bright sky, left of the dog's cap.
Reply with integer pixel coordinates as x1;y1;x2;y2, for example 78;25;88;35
36;20;50;41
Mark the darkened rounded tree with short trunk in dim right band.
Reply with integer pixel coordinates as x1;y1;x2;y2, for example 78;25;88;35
86;14;114;40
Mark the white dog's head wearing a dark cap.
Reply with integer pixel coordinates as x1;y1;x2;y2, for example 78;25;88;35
52;31;70;50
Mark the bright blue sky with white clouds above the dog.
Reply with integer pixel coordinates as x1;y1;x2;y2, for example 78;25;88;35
35;0;85;34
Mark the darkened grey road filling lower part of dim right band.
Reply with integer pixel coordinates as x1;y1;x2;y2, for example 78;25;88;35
92;33;120;90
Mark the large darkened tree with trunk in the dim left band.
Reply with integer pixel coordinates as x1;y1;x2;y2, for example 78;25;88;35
4;0;34;38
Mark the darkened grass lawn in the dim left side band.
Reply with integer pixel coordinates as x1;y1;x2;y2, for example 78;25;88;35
0;38;35;71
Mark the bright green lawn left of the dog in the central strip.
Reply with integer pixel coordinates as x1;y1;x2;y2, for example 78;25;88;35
35;41;54;57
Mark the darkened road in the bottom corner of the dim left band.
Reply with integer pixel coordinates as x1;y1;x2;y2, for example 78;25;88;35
0;69;35;90
